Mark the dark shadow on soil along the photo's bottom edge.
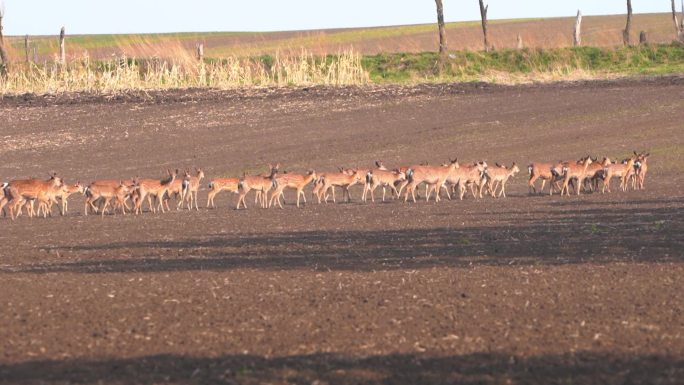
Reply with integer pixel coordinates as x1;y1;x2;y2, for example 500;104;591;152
0;352;684;385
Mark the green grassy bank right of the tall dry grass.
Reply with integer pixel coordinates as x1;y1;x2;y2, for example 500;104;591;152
362;43;684;83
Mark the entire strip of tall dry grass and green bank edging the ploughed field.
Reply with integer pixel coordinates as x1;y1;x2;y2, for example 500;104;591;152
0;43;684;94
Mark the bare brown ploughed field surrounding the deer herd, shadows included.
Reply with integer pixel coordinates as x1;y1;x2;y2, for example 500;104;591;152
0;77;684;384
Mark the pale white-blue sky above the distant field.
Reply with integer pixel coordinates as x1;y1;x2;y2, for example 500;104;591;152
0;0;679;35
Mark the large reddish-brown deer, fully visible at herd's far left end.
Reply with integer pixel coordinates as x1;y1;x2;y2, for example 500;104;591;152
5;172;62;220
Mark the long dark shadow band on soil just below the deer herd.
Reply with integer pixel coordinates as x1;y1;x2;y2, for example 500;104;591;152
0;207;684;273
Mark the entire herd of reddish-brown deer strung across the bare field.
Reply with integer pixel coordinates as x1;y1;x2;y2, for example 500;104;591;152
0;151;649;219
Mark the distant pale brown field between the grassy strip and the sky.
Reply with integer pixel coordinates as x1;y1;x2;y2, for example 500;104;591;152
4;13;674;60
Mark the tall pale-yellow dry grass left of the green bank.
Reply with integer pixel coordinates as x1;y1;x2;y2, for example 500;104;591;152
0;40;369;94
